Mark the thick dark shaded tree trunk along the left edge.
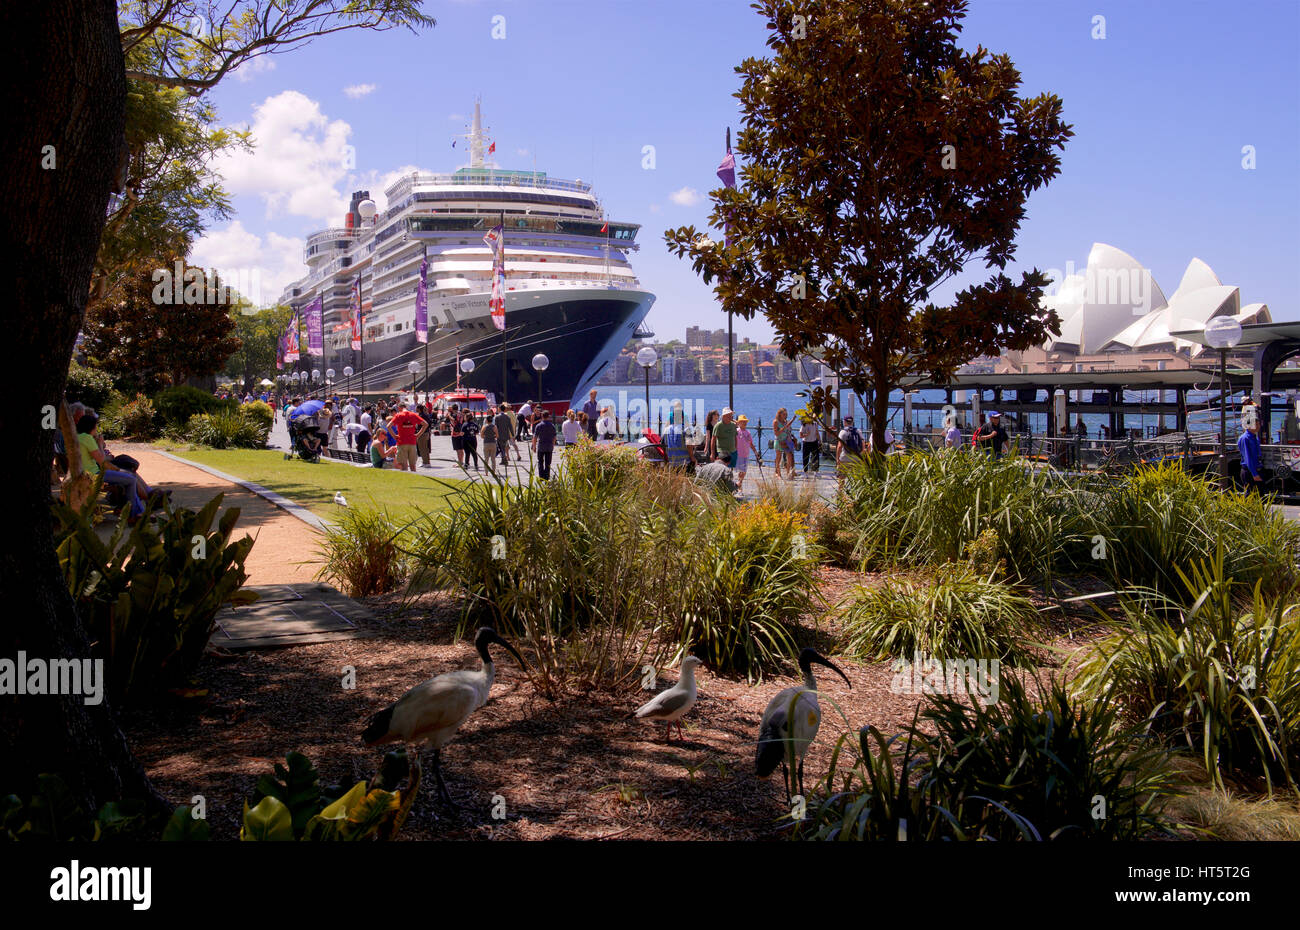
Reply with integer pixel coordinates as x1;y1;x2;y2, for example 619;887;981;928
0;0;164;813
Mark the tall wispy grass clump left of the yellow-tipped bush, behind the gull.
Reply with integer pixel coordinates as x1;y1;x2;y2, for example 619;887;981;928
411;471;702;696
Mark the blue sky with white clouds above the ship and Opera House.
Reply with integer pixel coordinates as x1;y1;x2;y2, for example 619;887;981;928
194;0;1300;341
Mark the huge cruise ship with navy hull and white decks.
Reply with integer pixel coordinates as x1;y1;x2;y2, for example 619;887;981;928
281;103;655;410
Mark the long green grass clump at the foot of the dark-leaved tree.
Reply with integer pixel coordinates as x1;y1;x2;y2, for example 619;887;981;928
842;451;1091;579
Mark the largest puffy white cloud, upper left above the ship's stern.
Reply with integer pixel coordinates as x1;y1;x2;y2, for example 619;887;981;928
213;91;356;225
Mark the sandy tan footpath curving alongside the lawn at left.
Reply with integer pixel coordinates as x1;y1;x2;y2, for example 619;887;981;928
111;442;320;584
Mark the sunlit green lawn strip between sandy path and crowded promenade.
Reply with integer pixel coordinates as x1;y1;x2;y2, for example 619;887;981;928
156;442;468;520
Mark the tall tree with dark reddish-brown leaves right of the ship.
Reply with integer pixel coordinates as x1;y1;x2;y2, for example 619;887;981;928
664;0;1073;449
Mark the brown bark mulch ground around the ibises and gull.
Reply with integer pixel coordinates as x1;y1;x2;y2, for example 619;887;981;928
124;568;1100;840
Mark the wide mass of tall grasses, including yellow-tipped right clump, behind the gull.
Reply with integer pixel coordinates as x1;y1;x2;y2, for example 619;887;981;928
408;450;819;695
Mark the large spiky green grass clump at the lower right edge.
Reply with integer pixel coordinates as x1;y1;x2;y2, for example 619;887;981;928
1075;555;1300;791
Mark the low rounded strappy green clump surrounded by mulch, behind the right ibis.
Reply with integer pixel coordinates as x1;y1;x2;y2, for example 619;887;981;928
841;563;1037;665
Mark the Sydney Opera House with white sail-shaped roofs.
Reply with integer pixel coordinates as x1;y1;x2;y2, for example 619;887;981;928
993;242;1273;373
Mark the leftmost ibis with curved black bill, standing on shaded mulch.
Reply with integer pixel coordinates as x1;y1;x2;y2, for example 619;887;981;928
361;627;524;808
